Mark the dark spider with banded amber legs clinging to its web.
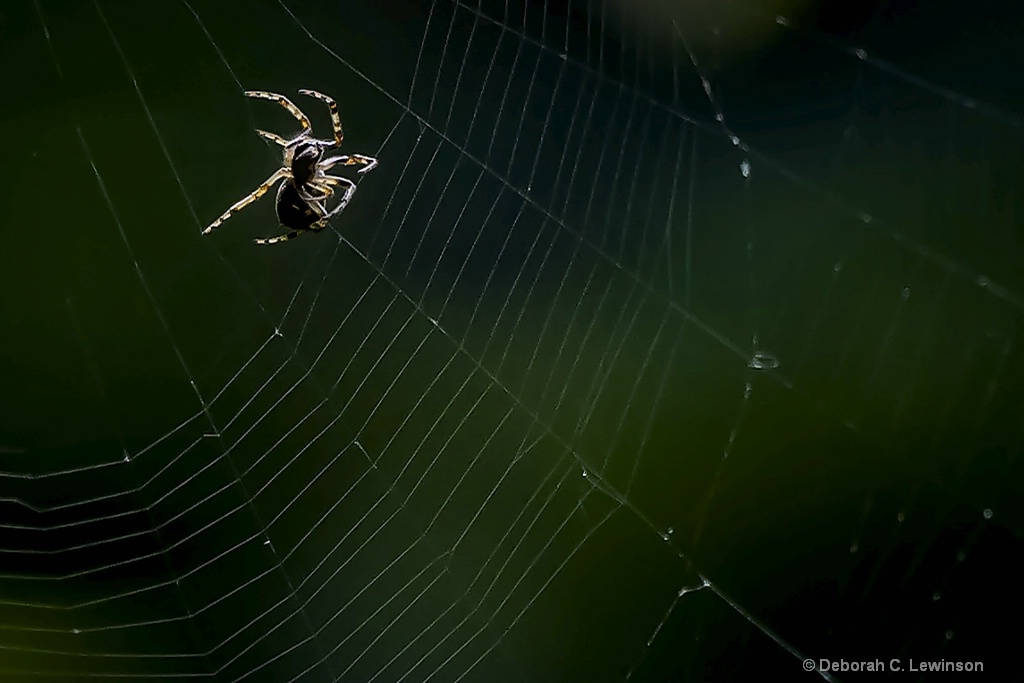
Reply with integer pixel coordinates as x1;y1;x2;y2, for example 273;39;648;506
203;90;377;245
